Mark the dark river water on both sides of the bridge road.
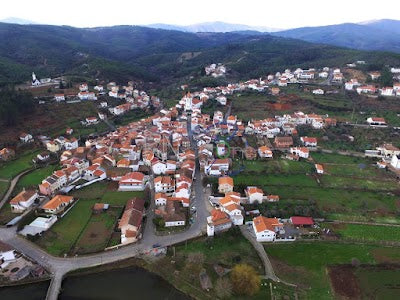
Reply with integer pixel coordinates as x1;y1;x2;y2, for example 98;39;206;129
0;267;190;300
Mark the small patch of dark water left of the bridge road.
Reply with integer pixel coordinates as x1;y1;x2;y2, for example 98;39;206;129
0;282;49;300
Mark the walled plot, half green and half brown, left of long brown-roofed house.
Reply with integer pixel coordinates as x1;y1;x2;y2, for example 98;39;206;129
37;183;143;255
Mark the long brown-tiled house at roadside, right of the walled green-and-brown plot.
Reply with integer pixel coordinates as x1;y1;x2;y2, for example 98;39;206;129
118;198;144;244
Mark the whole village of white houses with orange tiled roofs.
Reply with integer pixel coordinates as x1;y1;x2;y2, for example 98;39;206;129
0;62;400;298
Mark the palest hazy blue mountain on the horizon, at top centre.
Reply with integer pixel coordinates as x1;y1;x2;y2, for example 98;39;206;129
147;22;279;32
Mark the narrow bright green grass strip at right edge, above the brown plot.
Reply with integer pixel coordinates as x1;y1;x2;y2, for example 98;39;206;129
335;224;400;242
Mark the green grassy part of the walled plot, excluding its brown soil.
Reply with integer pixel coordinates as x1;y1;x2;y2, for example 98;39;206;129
37;183;143;256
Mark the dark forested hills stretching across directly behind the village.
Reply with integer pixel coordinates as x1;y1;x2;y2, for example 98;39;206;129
0;23;400;85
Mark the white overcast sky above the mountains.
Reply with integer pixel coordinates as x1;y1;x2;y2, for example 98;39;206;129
0;0;400;28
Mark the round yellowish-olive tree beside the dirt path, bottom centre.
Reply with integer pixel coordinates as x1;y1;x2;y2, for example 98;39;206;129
231;264;261;296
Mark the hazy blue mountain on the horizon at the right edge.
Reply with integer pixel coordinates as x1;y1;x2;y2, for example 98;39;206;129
273;20;400;53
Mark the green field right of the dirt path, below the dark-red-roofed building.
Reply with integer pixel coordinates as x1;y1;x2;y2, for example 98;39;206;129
265;242;394;299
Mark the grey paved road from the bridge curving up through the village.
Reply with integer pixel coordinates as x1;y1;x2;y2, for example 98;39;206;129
0;113;208;300
